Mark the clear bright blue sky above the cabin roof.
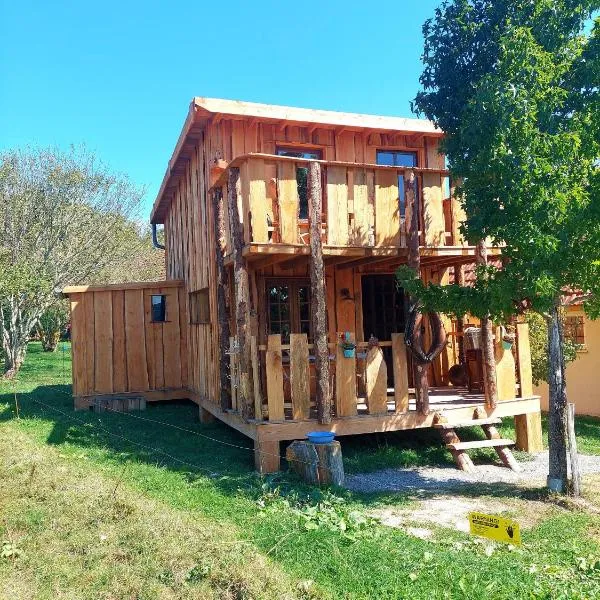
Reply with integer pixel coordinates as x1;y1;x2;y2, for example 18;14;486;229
0;0;438;214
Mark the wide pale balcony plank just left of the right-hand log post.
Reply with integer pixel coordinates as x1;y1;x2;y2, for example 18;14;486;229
375;170;400;246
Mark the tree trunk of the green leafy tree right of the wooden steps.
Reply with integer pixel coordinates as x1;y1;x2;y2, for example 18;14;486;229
548;300;567;493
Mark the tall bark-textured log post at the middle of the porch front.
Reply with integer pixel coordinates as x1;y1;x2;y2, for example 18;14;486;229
308;161;331;425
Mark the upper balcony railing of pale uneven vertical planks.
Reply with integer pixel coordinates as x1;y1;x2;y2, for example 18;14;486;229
213;154;461;251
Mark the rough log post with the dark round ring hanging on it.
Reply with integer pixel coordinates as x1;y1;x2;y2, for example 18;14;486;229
404;170;429;416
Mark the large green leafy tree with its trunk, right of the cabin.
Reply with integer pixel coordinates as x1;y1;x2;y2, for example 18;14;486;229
400;0;600;489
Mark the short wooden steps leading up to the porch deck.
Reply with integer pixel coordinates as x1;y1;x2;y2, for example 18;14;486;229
433;414;521;472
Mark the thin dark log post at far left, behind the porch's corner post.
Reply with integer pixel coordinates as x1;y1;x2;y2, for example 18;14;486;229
213;190;232;410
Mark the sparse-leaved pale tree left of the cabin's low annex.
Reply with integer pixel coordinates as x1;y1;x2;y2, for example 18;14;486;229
0;148;155;377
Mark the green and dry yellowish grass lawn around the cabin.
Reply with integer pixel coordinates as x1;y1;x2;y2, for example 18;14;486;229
0;344;600;600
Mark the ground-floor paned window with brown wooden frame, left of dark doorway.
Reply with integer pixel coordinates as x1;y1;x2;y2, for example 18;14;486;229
266;279;312;344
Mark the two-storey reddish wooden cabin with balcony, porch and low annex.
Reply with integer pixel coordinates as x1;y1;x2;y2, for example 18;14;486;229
65;98;541;472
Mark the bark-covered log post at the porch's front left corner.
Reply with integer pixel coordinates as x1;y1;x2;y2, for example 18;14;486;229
227;167;254;419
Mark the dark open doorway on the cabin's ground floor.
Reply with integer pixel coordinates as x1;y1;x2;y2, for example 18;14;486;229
362;275;404;386
